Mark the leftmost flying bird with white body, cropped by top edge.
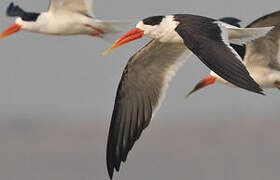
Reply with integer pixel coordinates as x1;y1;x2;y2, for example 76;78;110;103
0;0;131;41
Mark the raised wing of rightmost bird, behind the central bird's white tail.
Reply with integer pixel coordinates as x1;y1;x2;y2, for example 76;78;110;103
244;11;280;70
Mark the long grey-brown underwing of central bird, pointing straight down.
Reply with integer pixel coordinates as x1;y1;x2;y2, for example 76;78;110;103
107;40;190;178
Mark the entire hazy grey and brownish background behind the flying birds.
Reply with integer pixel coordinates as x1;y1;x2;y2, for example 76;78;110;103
0;0;280;180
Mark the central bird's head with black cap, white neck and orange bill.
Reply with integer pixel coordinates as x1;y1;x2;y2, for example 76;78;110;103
104;15;182;54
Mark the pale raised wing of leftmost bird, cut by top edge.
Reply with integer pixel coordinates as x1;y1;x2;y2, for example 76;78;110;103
48;0;93;17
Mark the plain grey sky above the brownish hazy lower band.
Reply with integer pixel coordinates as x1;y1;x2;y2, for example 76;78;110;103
0;0;278;121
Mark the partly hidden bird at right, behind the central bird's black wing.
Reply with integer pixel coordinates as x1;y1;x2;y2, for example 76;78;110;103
186;11;280;97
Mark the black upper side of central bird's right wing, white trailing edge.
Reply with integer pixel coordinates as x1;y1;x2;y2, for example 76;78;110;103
175;16;262;94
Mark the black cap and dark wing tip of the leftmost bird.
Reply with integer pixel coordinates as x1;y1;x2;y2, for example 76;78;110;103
6;2;40;21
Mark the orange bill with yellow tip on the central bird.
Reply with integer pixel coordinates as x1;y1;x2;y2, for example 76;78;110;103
103;28;144;55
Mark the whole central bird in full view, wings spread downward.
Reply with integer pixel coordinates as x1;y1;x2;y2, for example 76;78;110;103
105;14;273;178
